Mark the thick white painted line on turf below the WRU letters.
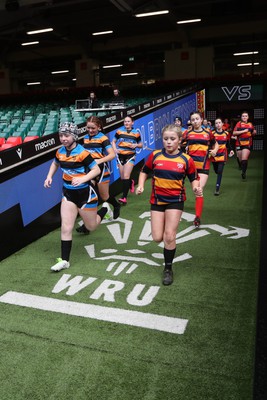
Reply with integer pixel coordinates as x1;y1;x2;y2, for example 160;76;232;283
0;291;188;335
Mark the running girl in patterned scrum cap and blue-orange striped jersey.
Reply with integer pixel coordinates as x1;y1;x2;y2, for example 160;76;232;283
44;123;107;272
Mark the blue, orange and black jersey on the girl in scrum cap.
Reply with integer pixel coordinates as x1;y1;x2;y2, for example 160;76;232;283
54;144;97;190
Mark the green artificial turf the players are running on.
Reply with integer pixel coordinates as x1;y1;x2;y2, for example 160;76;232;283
0;152;263;400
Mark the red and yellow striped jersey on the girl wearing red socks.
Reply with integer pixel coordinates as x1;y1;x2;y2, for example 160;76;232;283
182;129;216;170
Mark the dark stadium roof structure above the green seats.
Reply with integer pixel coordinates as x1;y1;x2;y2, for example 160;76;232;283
0;0;267;88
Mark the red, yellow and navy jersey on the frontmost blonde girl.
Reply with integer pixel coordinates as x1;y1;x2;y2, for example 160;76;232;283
142;149;197;205
